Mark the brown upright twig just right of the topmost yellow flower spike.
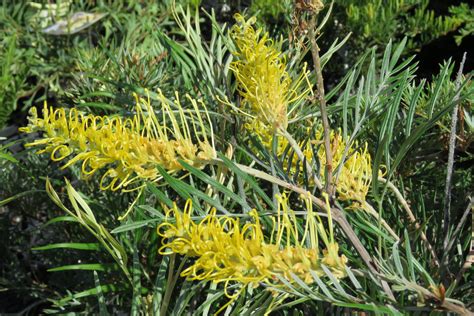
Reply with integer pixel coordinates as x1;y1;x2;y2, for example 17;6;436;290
308;14;335;198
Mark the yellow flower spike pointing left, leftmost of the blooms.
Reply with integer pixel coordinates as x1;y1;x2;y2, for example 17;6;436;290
20;91;216;190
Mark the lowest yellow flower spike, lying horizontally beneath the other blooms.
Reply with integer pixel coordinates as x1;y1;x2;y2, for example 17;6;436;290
158;195;347;298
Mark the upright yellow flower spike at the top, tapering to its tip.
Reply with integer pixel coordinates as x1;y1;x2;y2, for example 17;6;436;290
230;14;311;145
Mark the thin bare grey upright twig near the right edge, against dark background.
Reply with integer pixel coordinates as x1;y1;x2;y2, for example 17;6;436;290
443;53;466;249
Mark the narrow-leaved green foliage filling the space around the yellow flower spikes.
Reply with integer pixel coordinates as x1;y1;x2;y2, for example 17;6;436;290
0;0;474;315
